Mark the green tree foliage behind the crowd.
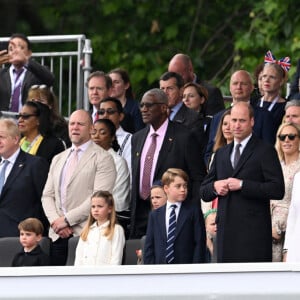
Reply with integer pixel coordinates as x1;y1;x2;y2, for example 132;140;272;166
0;0;300;98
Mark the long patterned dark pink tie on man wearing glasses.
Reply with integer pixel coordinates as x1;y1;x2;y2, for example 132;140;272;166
140;133;158;200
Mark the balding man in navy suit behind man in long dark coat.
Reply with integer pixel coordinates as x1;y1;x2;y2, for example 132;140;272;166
204;70;276;164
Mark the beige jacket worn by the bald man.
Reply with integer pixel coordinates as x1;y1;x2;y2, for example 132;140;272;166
42;142;116;241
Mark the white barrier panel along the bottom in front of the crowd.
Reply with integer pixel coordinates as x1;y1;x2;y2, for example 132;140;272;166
0;263;300;300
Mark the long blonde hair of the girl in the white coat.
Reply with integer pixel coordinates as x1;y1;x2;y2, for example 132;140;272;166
80;191;117;241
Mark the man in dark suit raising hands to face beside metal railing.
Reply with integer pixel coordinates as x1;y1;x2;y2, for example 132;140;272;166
0;33;54;112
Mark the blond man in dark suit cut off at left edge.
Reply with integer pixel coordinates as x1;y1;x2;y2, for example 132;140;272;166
0;119;49;237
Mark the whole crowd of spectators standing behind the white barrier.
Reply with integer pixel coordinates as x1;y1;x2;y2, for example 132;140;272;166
0;34;300;265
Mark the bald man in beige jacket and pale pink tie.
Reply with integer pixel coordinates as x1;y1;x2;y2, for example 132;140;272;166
42;110;116;265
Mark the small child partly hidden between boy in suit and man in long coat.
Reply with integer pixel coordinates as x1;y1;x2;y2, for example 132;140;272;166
204;208;217;262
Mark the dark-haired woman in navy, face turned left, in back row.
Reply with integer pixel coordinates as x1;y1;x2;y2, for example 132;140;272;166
108;68;145;133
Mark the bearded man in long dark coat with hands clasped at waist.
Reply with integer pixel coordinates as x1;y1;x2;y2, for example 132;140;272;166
200;102;284;262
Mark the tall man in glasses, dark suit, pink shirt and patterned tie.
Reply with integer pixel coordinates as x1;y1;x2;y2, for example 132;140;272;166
130;89;206;238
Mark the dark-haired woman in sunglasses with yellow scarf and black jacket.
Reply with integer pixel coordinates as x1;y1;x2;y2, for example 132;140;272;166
17;101;65;164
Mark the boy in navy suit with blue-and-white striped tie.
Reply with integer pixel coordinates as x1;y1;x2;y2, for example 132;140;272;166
144;168;206;264
